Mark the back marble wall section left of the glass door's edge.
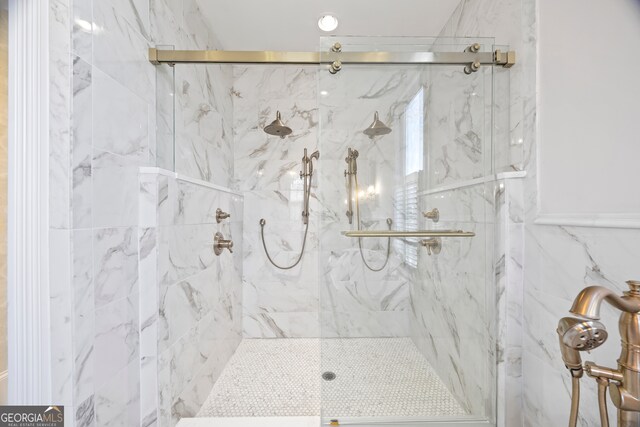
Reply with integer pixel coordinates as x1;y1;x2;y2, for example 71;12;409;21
233;66;323;338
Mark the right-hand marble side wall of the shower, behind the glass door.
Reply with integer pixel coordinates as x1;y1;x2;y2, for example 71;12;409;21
396;45;497;417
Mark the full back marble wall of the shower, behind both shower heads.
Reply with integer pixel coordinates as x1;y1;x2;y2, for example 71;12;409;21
233;67;417;337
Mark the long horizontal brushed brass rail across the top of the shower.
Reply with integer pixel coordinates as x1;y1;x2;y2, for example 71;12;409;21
149;48;515;68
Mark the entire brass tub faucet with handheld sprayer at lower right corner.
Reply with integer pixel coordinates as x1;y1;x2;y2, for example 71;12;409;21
557;280;640;427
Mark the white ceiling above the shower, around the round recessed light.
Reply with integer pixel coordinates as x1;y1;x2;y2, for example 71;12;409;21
200;0;459;51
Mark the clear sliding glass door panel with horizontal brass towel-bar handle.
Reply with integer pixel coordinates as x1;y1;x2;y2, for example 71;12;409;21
316;37;496;425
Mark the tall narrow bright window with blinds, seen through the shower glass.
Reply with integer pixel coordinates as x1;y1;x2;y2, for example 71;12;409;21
394;88;424;267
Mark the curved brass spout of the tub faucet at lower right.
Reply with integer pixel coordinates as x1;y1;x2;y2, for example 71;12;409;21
569;286;640;320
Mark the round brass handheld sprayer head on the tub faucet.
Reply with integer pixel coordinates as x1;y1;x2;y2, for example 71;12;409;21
556;317;609;375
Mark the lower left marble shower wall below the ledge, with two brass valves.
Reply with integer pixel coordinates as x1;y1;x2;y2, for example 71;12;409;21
140;173;243;426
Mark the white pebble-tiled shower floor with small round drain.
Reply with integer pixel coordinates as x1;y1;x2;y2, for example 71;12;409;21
198;338;466;417
